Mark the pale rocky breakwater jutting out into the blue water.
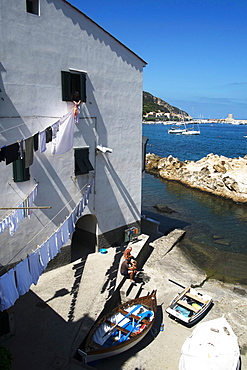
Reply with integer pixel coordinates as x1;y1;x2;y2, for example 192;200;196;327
146;153;247;203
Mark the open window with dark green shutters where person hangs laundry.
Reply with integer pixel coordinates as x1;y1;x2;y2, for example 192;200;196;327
62;71;86;103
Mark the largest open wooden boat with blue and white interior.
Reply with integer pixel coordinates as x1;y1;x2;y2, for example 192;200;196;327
78;291;157;363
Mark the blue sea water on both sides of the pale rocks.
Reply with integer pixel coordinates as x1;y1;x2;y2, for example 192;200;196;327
142;124;247;285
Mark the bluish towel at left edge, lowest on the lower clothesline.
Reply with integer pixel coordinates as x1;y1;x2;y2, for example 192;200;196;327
0;269;19;311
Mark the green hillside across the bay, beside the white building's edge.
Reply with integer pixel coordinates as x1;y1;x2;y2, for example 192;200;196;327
143;91;190;118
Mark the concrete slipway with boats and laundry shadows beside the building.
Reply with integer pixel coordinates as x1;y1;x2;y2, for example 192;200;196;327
2;230;247;370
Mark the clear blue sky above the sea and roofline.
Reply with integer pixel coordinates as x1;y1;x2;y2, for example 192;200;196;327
69;0;247;119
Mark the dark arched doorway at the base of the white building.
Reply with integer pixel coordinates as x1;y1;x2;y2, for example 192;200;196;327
71;215;97;262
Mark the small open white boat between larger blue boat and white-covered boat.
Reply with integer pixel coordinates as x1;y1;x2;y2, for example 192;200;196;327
166;287;213;325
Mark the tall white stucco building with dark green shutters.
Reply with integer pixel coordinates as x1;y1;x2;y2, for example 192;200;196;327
0;0;146;275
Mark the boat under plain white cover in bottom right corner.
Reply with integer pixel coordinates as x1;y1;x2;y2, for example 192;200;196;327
179;317;241;370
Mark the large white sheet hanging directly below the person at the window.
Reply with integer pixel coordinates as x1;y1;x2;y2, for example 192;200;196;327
51;112;74;155
